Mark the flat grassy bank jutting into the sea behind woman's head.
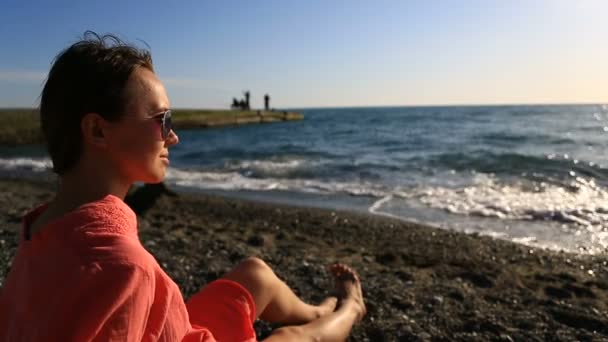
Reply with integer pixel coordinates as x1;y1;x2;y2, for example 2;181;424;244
0;109;303;145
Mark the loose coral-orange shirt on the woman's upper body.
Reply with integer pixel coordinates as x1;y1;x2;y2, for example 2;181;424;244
0;195;239;342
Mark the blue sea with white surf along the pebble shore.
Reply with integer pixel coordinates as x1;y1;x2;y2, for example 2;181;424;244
0;104;608;254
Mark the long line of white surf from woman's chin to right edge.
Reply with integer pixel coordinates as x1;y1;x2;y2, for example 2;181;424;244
167;165;608;227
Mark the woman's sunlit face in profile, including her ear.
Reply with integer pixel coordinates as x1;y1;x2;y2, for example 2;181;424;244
108;67;179;183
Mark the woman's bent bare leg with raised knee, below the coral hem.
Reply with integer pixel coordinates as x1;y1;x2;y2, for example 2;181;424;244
223;258;337;324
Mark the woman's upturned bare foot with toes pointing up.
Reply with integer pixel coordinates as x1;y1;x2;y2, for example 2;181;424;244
329;264;367;321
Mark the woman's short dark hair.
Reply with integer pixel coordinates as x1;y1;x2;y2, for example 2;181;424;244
40;31;154;175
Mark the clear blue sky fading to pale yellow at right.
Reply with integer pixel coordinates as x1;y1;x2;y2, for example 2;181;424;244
0;0;608;108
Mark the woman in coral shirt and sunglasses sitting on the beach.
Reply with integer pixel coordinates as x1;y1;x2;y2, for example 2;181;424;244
0;32;365;341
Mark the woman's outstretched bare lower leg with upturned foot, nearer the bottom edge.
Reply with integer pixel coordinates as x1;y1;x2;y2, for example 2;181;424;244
264;265;365;342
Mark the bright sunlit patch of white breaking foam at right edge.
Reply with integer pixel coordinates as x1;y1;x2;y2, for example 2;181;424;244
399;175;608;230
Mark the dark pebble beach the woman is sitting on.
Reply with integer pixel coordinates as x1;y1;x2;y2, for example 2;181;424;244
0;179;608;341
